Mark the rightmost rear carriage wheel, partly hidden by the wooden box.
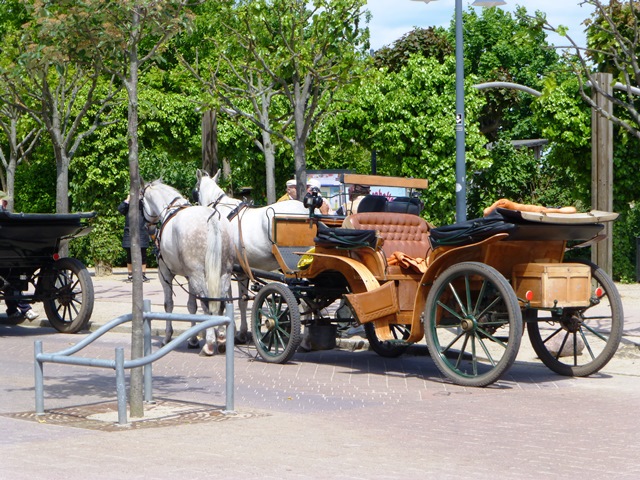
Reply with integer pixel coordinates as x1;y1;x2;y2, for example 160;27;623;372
527;260;624;377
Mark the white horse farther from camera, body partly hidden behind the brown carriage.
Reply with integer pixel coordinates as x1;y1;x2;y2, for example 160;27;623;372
195;170;309;343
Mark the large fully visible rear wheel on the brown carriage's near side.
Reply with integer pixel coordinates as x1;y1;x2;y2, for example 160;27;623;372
425;262;522;387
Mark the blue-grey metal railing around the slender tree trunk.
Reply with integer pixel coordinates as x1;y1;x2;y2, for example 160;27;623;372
34;300;235;425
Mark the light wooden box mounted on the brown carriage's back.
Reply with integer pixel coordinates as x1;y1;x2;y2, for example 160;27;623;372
511;263;591;308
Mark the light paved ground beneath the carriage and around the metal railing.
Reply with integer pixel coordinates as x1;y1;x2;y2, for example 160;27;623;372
0;272;640;480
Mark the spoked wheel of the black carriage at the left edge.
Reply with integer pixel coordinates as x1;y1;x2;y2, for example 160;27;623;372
39;258;94;333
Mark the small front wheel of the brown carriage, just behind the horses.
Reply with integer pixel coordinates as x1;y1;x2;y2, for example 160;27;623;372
251;283;302;363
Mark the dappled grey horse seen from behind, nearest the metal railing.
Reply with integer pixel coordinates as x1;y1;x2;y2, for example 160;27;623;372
142;180;234;355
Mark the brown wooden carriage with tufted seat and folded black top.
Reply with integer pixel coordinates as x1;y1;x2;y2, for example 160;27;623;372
232;175;623;386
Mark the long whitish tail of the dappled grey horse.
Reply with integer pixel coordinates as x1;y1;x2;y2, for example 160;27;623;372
205;216;233;315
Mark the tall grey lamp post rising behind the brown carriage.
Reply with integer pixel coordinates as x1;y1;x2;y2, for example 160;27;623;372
412;0;506;222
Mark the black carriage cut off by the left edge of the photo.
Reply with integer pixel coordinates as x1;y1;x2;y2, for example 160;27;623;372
0;212;95;333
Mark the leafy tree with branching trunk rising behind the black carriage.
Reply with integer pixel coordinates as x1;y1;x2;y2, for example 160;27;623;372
3;1;116;218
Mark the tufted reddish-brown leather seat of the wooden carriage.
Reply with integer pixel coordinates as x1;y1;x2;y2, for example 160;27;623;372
343;212;431;258
